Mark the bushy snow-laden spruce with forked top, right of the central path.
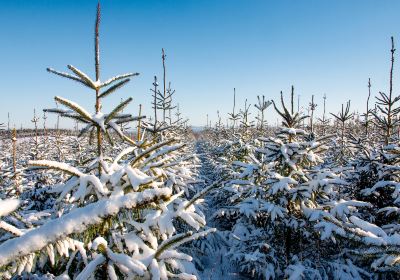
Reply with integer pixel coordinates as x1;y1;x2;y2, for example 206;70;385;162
212;89;356;279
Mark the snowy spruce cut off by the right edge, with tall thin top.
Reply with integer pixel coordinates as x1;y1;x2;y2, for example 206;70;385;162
312;38;400;279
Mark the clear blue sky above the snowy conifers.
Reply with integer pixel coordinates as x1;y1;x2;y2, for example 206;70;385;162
0;0;400;127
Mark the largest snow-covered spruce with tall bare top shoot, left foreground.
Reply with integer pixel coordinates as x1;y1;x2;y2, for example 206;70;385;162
0;3;214;279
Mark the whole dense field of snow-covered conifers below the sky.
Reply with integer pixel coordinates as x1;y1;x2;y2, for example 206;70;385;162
0;3;400;280
